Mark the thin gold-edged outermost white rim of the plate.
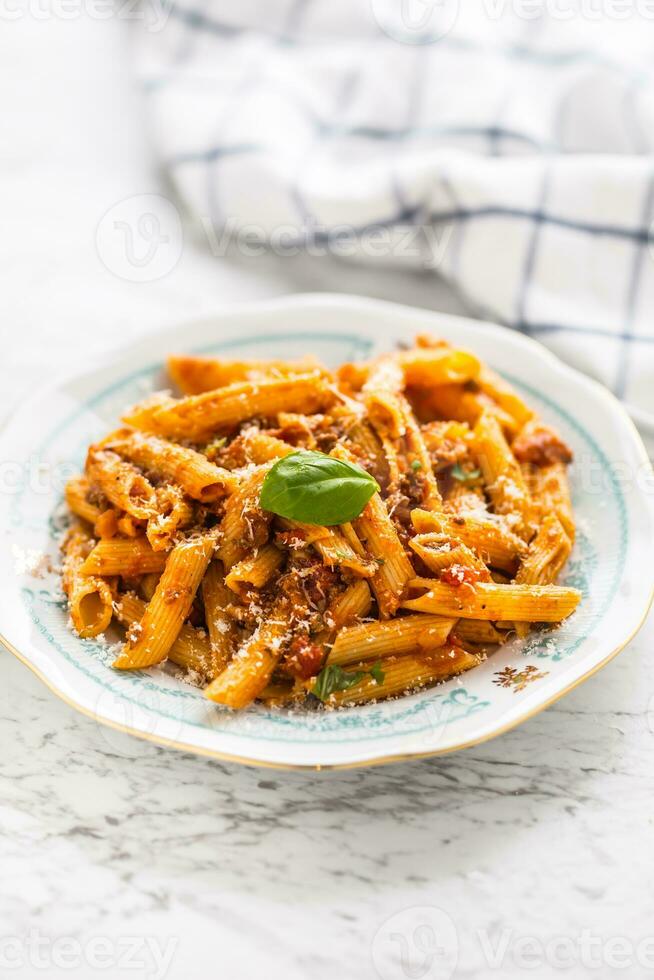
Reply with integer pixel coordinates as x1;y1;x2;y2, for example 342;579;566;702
0;293;654;771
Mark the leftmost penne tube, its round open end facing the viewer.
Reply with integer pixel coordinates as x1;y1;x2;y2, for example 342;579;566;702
62;526;112;640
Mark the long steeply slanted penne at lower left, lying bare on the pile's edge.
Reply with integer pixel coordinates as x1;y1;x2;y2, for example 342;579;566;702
113;531;216;670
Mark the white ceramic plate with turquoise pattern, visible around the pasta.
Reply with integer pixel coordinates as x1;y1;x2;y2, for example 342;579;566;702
0;295;654;767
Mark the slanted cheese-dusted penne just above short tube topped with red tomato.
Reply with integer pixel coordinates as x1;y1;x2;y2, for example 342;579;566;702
411;509;526;573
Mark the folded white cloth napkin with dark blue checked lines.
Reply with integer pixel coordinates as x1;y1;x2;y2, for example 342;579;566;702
139;0;654;429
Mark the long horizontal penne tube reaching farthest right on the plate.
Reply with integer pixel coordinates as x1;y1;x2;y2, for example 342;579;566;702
403;578;581;623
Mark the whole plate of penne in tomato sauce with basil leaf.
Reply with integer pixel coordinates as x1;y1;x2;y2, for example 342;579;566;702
0;295;654;768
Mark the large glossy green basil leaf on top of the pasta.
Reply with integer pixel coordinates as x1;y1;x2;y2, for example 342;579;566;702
260;449;379;527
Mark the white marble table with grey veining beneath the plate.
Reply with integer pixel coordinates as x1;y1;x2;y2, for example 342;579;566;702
0;9;654;980
